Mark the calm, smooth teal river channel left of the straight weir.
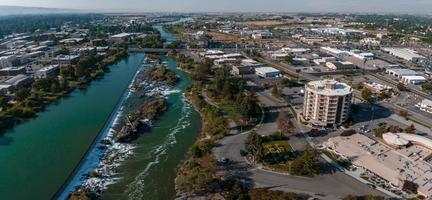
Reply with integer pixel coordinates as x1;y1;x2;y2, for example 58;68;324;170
0;53;145;199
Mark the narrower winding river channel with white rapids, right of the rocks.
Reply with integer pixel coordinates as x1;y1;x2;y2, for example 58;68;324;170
103;26;201;199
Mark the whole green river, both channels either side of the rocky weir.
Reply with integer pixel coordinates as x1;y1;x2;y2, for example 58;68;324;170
0;22;197;200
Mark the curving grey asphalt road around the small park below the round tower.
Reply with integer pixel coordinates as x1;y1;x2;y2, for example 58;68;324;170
213;132;385;199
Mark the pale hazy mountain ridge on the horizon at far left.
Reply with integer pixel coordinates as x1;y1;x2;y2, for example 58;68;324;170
0;5;82;16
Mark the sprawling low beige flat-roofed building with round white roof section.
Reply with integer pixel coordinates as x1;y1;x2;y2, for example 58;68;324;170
326;133;432;199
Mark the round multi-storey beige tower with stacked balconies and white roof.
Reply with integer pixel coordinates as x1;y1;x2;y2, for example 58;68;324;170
303;80;352;127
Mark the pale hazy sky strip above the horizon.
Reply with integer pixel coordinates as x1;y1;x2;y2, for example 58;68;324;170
0;0;432;14
